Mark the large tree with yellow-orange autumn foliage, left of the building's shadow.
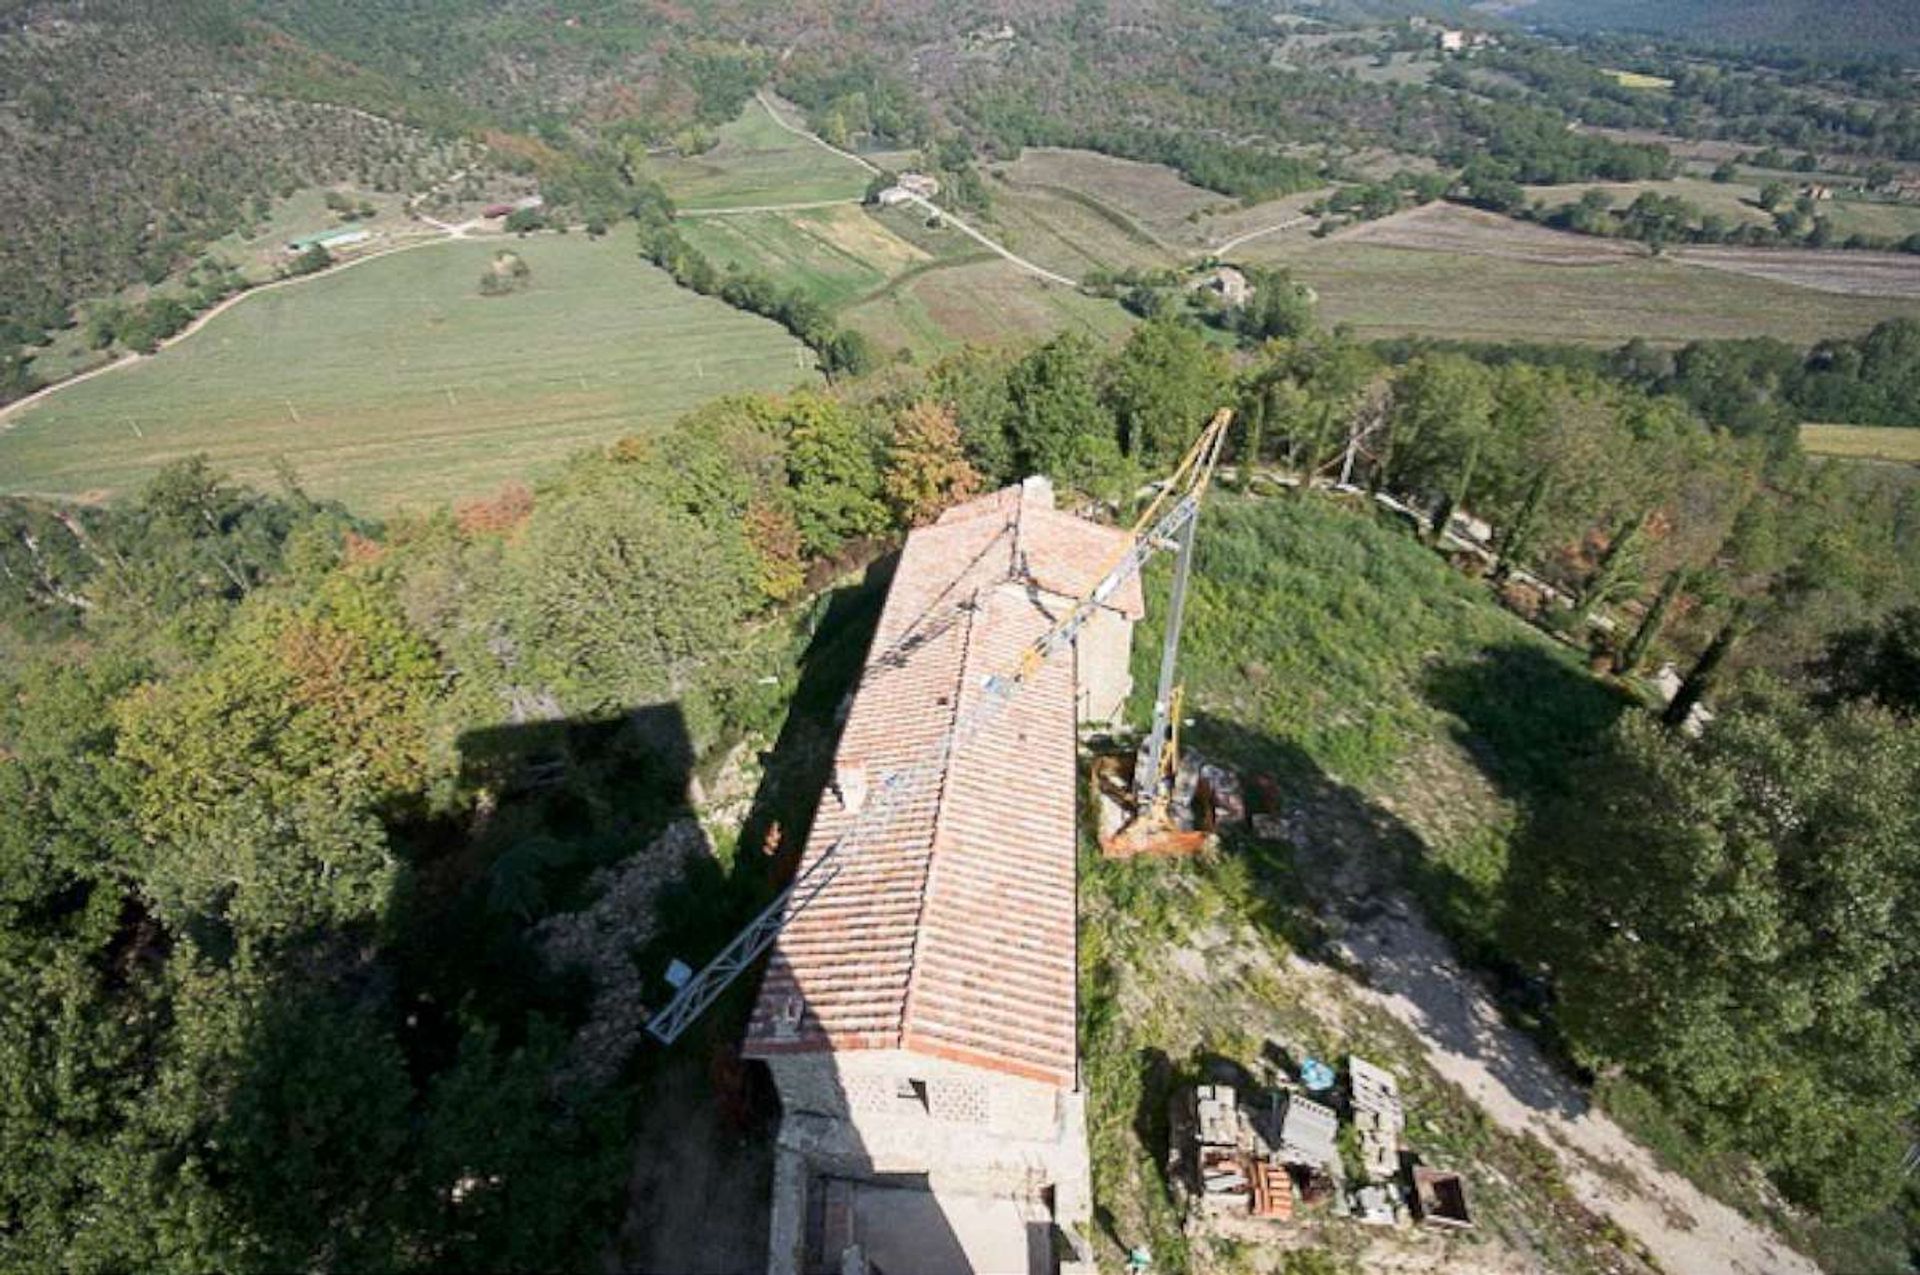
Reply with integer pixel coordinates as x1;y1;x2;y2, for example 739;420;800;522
117;580;440;935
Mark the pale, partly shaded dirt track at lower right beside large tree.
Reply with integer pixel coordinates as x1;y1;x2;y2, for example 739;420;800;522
1342;897;1818;1275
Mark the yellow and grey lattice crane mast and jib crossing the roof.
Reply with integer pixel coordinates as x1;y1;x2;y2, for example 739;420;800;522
647;407;1233;1045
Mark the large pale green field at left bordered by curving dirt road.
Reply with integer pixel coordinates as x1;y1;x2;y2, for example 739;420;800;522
0;236;816;513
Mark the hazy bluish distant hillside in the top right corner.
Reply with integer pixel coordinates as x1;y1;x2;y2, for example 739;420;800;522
1486;0;1920;56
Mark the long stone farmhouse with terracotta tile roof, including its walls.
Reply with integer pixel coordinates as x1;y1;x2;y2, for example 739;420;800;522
745;478;1140;1275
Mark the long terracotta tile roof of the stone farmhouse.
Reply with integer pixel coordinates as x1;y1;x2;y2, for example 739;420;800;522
745;486;1140;1087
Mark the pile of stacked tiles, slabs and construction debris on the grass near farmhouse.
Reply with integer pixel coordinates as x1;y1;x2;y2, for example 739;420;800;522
1169;1058;1473;1242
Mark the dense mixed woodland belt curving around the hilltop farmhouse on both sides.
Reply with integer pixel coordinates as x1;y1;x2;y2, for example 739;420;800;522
0;299;1920;1271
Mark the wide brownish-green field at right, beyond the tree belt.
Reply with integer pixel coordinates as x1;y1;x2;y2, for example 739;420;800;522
1267;236;1920;346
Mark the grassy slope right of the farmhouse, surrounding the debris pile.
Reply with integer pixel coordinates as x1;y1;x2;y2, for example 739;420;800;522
1081;493;1642;1271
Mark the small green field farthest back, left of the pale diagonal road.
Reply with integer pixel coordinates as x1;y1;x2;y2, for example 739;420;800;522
647;102;872;207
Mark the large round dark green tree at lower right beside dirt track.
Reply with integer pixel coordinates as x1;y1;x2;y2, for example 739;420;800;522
1509;684;1920;1221
